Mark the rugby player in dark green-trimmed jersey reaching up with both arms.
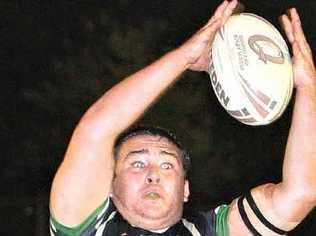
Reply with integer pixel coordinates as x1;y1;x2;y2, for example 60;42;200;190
50;0;316;236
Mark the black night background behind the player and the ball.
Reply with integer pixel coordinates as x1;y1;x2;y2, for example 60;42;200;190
0;0;316;236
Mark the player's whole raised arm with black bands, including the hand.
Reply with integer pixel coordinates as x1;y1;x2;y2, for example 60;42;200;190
229;8;316;236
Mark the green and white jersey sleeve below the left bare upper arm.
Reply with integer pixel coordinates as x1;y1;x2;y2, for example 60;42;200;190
49;198;114;236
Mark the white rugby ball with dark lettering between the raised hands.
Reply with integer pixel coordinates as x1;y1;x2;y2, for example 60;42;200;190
209;13;293;125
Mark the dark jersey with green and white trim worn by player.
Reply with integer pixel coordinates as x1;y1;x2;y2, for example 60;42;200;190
50;198;228;236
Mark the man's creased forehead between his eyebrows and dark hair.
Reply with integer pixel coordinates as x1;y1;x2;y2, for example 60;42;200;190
118;134;181;156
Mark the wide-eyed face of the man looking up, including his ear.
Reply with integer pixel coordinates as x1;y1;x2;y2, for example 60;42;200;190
112;135;189;229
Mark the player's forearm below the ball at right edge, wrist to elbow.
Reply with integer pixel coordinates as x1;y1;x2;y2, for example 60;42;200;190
274;86;316;221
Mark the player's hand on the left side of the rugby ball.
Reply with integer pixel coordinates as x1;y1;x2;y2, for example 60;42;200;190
179;0;238;71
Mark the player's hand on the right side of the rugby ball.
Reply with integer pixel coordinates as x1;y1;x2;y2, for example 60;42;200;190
281;8;316;89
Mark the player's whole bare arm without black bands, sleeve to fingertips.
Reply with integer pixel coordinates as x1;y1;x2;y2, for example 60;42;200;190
50;0;237;226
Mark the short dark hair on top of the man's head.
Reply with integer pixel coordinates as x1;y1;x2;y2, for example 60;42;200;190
114;126;191;176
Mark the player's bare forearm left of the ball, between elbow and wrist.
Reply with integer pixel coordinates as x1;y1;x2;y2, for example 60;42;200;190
81;50;188;139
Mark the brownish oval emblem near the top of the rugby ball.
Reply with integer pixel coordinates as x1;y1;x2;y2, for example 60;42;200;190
248;35;284;64
